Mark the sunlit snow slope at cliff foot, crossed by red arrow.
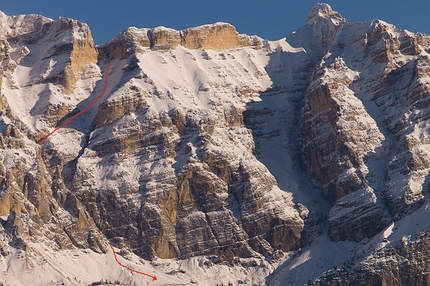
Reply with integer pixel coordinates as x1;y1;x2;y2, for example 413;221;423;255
0;240;273;285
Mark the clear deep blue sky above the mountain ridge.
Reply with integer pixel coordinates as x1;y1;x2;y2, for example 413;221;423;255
0;0;430;44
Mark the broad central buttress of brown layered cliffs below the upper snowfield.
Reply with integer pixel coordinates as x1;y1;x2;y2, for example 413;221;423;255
70;54;304;260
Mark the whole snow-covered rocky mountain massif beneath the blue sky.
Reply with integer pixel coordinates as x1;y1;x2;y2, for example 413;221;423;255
0;4;430;285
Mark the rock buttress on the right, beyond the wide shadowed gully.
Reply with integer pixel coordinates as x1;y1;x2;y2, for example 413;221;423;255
301;5;429;246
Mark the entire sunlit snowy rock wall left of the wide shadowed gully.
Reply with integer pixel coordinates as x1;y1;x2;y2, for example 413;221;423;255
0;8;306;270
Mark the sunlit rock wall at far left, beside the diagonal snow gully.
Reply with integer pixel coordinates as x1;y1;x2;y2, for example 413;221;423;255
0;14;107;264
